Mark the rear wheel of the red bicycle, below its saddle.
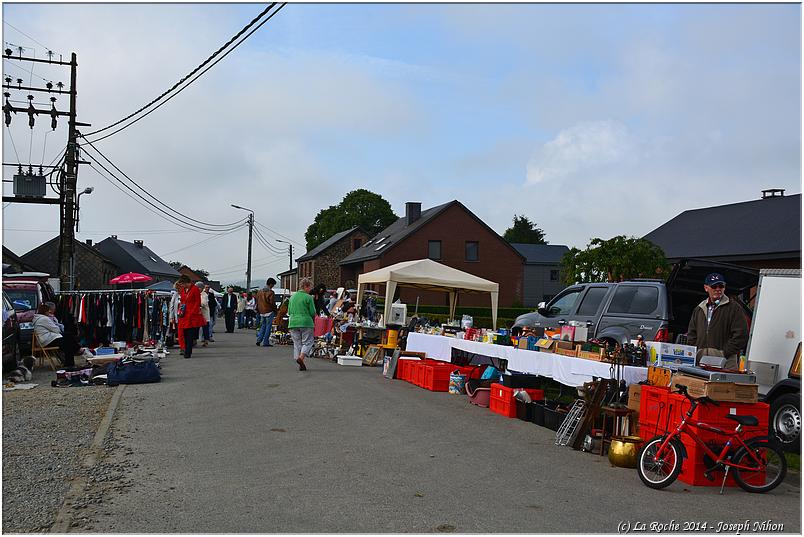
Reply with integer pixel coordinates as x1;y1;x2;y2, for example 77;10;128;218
732;438;787;492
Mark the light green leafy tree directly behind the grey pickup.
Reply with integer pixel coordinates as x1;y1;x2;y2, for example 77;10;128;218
561;235;670;285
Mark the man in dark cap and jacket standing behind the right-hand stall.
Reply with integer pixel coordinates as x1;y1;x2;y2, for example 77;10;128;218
687;272;748;369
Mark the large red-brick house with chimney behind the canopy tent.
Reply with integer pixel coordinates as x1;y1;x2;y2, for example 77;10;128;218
340;200;525;307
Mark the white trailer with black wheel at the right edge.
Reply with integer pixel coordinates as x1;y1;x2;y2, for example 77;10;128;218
746;269;802;451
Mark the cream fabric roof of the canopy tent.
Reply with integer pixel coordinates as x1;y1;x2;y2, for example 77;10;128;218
358;259;500;293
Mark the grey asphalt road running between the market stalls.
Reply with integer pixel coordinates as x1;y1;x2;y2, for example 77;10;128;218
81;331;801;533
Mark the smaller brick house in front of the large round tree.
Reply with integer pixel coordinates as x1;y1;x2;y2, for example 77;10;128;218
296;226;369;289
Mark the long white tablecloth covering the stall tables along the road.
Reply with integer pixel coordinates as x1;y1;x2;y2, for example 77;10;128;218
407;332;648;386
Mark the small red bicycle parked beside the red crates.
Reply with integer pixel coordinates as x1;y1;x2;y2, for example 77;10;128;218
637;384;787;494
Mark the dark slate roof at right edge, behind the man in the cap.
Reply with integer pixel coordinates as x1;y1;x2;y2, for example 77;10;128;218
645;194;801;259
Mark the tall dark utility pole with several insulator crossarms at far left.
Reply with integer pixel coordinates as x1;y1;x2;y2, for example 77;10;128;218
3;49;91;290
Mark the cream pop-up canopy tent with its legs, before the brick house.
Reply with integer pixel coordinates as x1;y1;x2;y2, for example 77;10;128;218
357;259;500;330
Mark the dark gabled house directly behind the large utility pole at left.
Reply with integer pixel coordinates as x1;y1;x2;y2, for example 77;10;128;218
21;237;120;289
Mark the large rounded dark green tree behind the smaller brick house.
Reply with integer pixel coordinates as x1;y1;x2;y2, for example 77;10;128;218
304;188;399;251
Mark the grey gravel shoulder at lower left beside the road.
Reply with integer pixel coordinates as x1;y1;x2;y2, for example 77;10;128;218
2;368;114;533
